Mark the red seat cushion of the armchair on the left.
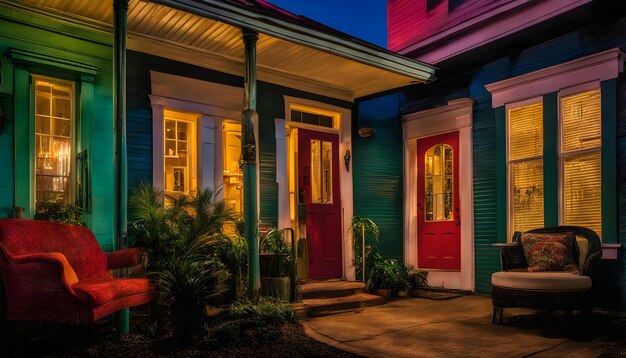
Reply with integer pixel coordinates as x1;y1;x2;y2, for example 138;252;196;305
72;278;154;307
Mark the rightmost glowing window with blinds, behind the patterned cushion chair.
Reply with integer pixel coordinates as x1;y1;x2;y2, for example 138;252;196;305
560;88;602;236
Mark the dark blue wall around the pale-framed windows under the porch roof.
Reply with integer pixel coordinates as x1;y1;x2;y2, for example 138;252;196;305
127;51;351;225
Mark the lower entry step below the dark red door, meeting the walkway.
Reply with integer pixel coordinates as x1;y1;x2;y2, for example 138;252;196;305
302;293;385;317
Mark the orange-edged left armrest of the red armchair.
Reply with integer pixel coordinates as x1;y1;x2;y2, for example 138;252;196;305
8;252;78;294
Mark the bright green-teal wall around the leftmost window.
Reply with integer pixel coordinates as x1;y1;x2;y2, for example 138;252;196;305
0;4;115;251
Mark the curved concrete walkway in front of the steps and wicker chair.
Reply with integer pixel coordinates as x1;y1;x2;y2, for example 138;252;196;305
304;295;612;358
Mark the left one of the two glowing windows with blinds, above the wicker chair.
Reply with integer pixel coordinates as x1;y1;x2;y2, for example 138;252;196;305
507;102;544;237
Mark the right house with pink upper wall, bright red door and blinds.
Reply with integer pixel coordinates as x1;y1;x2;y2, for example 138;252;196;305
376;0;626;310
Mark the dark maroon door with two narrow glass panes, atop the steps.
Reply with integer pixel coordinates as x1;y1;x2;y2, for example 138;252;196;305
298;129;342;279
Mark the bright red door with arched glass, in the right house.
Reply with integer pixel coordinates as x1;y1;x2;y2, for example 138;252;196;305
417;132;460;270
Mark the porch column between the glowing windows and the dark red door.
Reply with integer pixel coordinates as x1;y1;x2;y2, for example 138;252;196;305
241;30;261;298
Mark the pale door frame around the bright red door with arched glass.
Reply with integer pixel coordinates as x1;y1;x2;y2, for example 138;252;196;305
402;98;475;290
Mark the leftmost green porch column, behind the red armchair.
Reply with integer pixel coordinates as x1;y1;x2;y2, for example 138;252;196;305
113;0;129;333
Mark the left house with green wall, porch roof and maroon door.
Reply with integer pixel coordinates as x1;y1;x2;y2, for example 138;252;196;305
0;0;435;286
